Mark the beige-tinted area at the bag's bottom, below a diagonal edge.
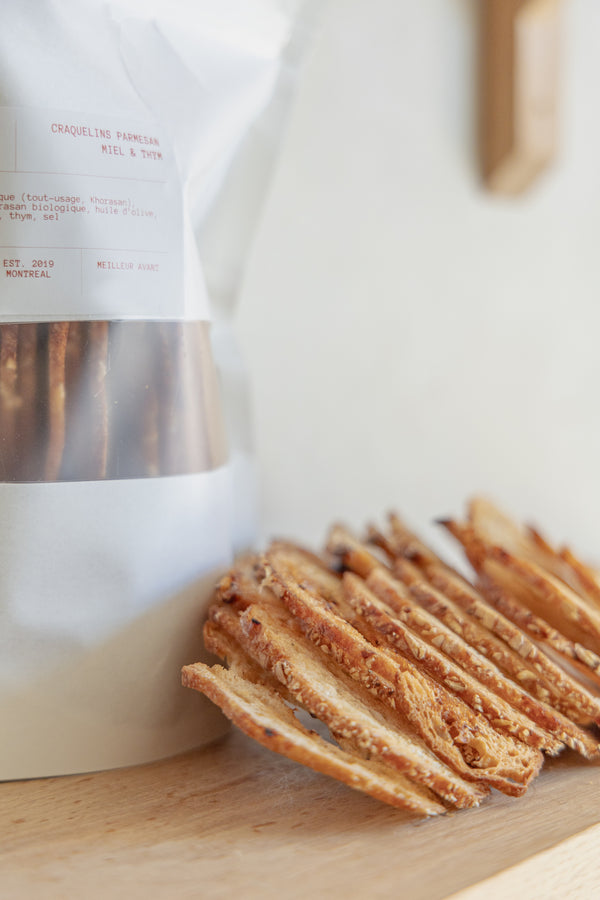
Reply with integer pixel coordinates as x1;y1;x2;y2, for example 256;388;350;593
0;576;228;779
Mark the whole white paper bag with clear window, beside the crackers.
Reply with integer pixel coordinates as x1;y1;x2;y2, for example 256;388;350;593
0;0;310;779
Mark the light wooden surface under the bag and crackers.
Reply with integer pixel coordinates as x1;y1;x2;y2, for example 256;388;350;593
0;732;600;900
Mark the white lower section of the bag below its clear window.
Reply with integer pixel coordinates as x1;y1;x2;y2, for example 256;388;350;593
0;466;231;779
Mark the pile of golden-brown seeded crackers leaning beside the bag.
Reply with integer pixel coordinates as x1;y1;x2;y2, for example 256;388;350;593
183;498;600;815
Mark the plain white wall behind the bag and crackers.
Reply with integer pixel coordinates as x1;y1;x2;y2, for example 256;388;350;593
237;0;600;560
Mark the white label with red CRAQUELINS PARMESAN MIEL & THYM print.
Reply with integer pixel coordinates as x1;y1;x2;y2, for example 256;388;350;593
0;107;208;321
